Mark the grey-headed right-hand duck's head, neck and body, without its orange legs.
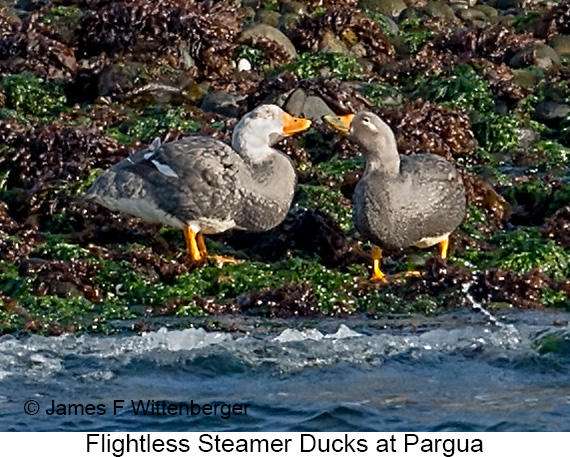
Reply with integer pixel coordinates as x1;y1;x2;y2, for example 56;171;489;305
326;112;466;248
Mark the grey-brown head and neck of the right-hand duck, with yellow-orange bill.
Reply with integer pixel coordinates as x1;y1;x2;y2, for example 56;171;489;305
324;111;399;172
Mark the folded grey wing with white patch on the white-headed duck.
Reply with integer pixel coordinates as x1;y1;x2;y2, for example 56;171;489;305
96;137;247;221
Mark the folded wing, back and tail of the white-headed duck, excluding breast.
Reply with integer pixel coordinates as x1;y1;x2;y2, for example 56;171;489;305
85;137;251;233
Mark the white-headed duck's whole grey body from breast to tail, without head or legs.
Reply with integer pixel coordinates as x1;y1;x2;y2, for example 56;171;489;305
84;107;296;234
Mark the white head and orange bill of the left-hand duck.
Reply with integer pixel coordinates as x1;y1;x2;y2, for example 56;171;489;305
232;105;311;161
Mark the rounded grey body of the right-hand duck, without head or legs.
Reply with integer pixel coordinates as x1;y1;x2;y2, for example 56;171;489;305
353;154;466;248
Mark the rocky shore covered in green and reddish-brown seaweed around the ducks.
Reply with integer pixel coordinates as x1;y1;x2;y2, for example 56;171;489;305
0;0;570;334
